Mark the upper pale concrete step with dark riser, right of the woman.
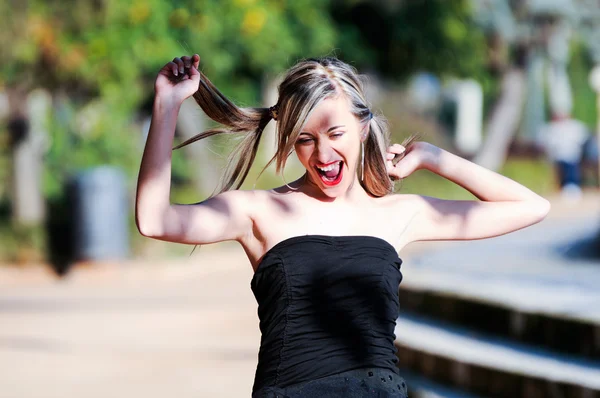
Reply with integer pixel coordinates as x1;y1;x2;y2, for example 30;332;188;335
400;215;600;360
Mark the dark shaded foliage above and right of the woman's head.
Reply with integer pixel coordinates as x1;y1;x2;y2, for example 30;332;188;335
333;0;488;80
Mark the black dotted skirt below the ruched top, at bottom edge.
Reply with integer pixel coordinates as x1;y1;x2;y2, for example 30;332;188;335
252;368;408;398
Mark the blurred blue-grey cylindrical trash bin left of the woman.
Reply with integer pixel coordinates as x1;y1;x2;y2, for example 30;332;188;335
69;166;129;261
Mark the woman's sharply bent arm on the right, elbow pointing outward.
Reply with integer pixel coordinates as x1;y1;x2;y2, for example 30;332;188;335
388;142;550;243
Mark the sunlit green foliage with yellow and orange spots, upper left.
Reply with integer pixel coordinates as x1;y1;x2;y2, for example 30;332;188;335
0;0;336;205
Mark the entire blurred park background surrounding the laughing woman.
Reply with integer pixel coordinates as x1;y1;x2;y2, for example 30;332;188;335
0;0;600;397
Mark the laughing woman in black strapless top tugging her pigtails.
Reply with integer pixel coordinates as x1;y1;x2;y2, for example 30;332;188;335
136;55;550;397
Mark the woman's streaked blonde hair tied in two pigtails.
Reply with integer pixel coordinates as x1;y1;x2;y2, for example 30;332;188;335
174;57;404;197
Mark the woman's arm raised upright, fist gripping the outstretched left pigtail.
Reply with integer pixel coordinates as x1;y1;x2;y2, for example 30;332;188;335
135;55;251;244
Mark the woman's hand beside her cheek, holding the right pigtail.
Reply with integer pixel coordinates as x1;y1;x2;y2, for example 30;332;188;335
385;141;441;180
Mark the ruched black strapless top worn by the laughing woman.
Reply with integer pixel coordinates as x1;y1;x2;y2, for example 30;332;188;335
251;235;402;392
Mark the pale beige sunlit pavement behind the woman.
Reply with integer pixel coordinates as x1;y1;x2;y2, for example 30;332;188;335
0;194;600;398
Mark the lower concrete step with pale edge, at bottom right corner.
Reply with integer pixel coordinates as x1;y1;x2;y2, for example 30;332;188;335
396;315;600;398
